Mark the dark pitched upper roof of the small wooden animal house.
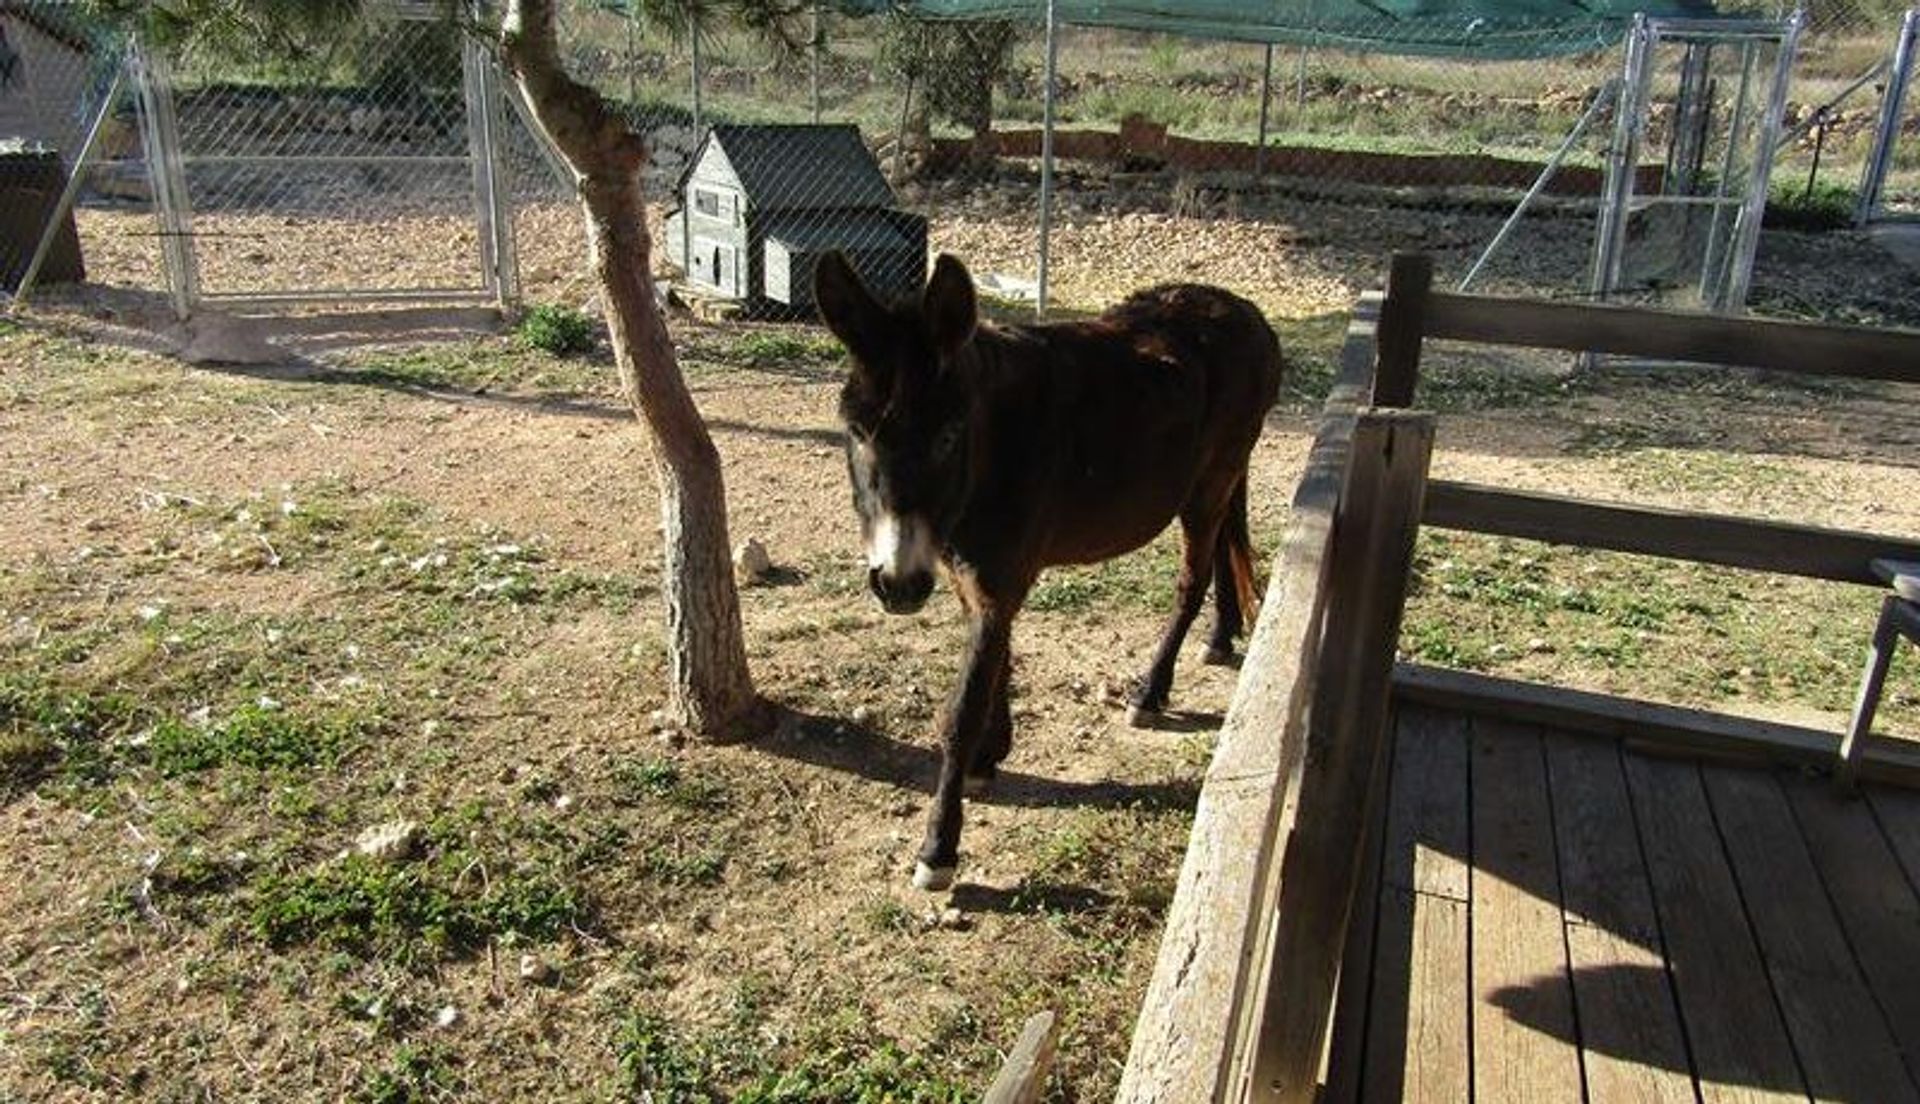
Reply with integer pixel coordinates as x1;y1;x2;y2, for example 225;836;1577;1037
680;125;893;211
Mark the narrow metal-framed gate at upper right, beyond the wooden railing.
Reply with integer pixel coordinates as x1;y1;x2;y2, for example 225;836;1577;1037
1592;13;1801;313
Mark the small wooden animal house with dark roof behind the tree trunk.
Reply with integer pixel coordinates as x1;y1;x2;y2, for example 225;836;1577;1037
666;125;927;315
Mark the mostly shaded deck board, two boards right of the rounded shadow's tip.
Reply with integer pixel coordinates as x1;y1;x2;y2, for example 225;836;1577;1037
1624;755;1807;1104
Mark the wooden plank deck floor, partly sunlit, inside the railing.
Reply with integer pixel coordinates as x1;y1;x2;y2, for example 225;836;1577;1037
1327;705;1920;1102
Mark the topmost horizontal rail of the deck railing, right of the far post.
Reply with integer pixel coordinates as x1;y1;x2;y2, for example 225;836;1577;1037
1423;292;1920;382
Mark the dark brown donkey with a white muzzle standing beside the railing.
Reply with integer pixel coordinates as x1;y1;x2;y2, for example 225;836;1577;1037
814;253;1283;889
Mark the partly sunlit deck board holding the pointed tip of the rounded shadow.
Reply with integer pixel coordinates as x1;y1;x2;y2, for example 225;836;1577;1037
1469;716;1580;1104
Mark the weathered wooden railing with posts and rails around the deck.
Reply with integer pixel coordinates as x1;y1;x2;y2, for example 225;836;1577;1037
1119;257;1920;1104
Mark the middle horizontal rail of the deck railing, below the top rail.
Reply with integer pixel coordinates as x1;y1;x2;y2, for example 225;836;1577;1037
1427;480;1920;588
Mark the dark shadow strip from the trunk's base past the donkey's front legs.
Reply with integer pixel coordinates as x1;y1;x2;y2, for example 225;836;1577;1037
753;710;1200;810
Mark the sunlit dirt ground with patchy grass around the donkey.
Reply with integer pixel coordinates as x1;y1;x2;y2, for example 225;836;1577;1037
11;193;1920;1100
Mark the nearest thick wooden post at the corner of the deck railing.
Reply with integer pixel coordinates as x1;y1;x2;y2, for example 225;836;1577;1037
1229;409;1434;1104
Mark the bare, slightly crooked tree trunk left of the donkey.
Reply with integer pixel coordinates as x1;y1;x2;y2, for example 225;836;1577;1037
501;0;770;741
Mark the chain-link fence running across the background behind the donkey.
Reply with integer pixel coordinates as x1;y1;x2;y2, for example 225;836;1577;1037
11;0;1920;324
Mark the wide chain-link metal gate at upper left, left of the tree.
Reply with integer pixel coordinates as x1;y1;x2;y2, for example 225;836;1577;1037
132;6;515;317
